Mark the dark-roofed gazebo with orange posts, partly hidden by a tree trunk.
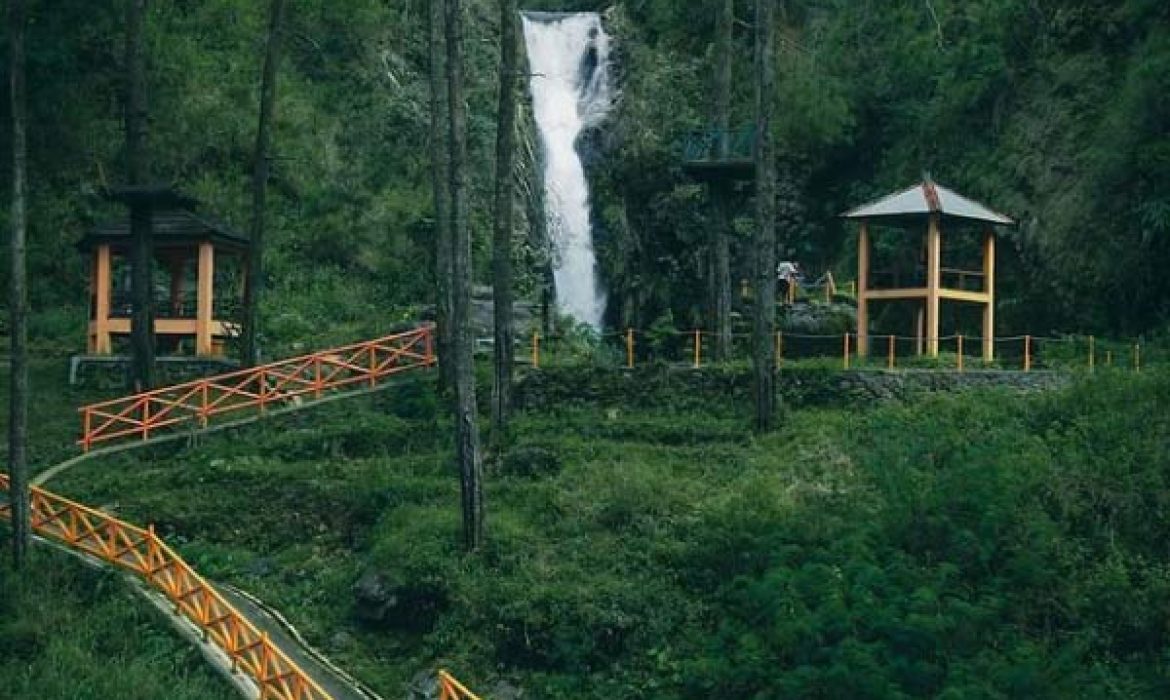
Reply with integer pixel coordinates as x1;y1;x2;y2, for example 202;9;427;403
77;193;249;357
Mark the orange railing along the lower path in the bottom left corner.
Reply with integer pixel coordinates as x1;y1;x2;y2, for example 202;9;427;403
0;474;331;700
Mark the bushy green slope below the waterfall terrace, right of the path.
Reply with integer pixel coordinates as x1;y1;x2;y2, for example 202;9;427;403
16;371;1170;699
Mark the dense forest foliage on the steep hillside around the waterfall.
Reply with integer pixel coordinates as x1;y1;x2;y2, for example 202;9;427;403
0;0;1170;341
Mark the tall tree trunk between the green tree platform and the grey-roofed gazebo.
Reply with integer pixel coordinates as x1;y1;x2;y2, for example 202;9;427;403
751;0;776;432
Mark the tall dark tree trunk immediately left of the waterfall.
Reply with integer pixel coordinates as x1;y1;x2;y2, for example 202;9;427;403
491;0;519;441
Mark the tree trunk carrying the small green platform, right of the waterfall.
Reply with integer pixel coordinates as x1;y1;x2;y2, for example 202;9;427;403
710;0;735;362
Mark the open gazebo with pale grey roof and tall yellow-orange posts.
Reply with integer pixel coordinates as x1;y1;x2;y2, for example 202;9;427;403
841;178;1013;362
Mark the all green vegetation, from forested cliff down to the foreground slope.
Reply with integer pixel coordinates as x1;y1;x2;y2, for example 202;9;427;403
0;0;1170;700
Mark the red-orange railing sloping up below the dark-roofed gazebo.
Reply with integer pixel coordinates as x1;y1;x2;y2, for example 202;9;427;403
77;327;435;452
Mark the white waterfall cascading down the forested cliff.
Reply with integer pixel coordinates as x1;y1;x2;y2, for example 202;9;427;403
524;12;613;329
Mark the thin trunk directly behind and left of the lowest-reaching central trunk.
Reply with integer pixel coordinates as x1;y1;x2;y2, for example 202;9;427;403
427;0;455;392
